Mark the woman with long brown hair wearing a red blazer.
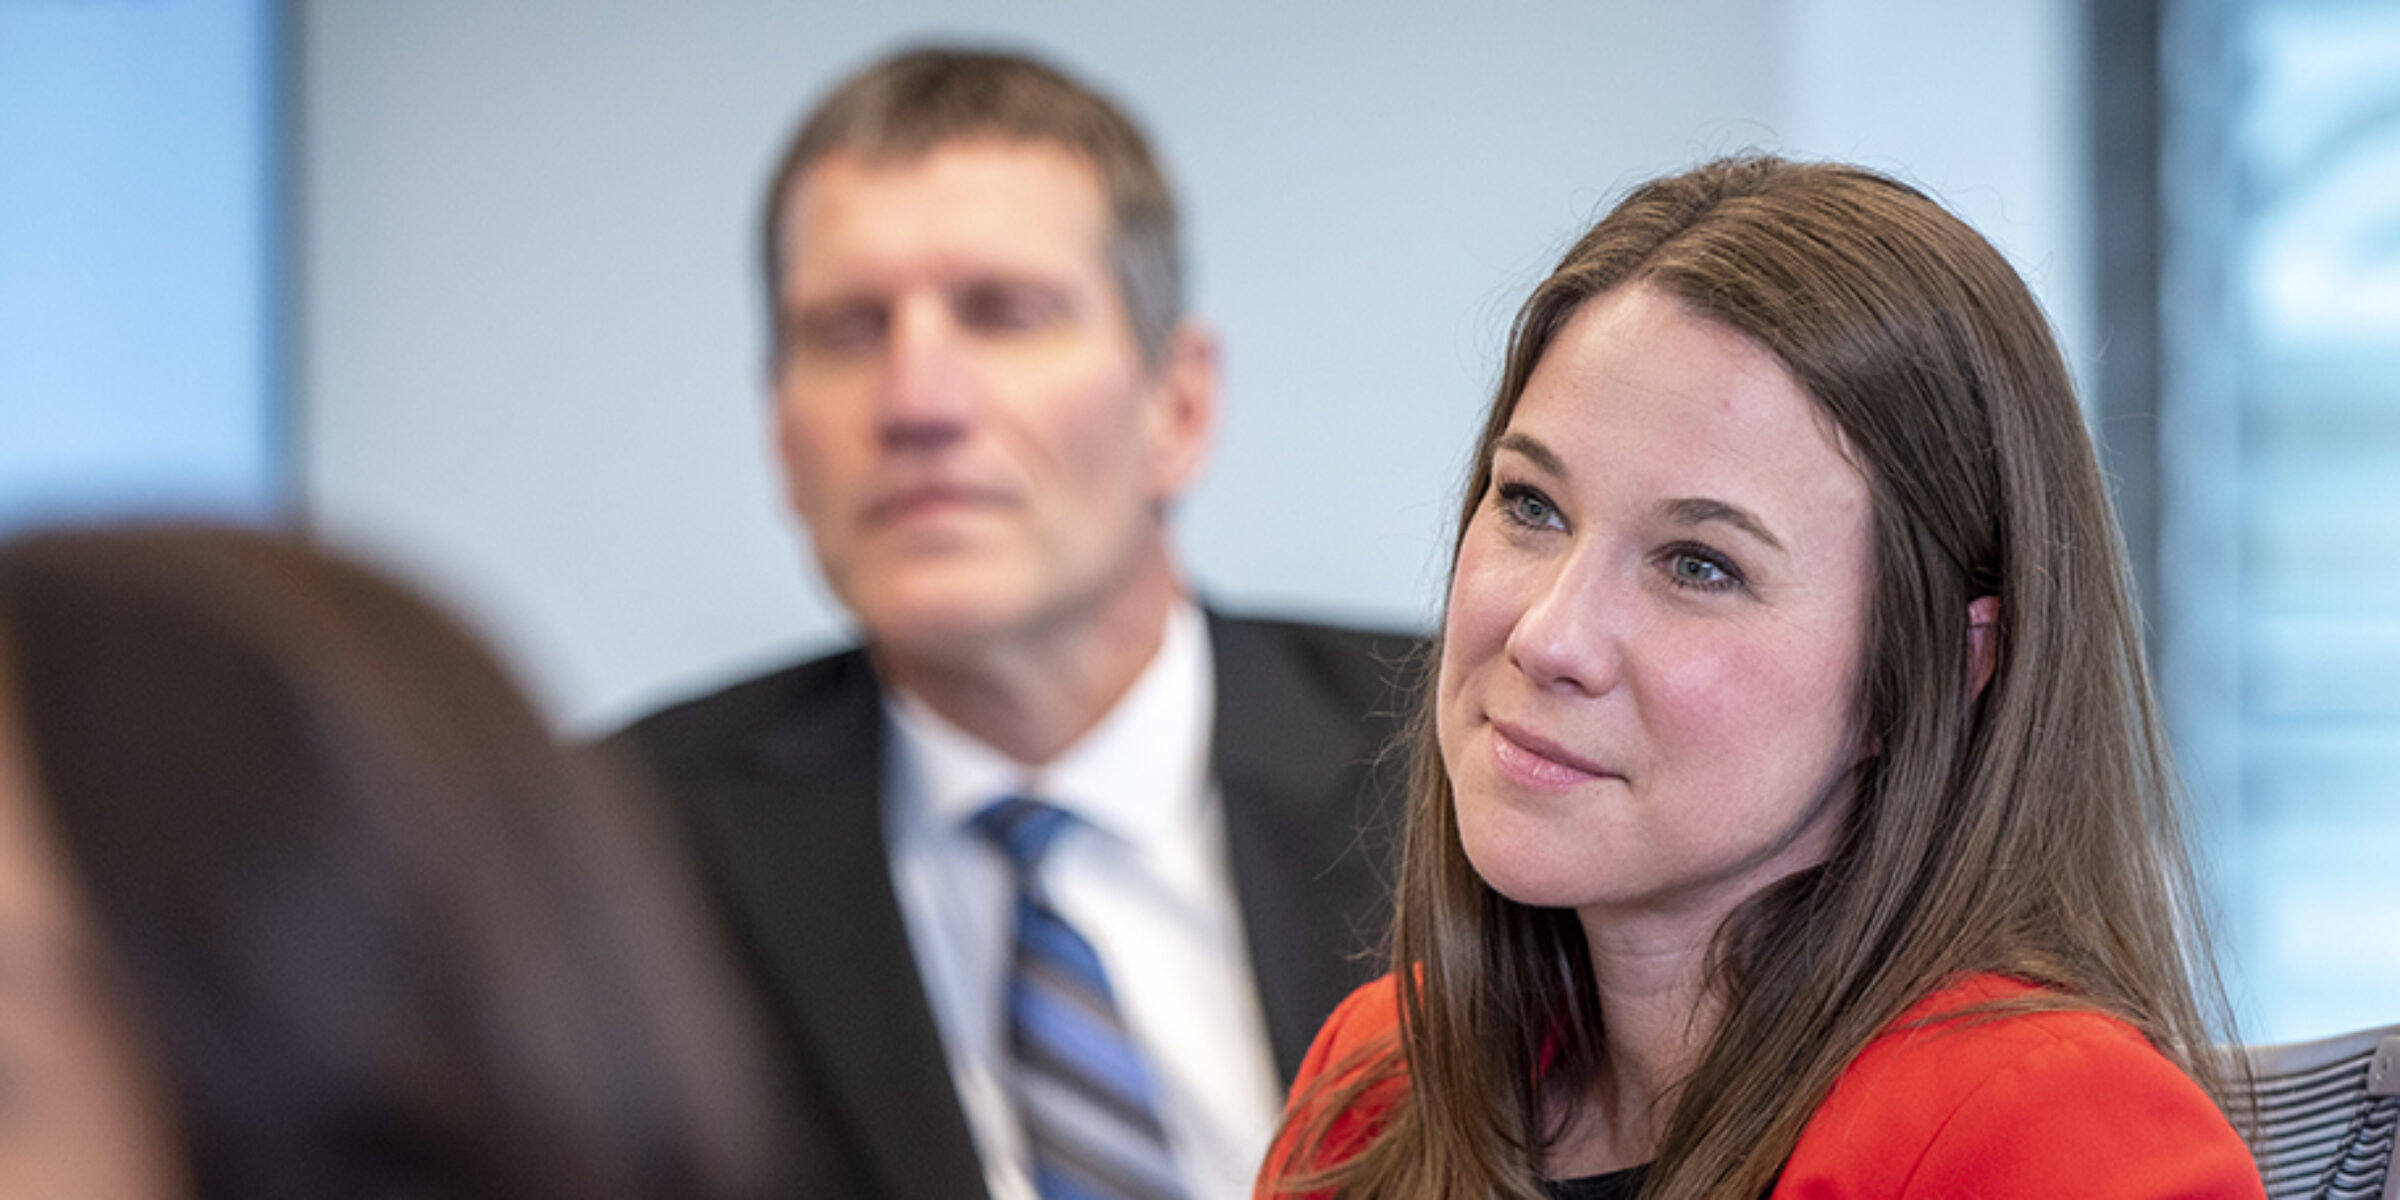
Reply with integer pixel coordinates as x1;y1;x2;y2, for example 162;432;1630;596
1260;158;2261;1198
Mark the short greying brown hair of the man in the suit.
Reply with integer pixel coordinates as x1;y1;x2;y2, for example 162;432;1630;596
758;46;1183;365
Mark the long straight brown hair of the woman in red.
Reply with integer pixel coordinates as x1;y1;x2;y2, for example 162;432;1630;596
1294;158;2225;1200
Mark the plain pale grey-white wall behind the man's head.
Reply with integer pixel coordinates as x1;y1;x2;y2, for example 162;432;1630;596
300;0;2088;727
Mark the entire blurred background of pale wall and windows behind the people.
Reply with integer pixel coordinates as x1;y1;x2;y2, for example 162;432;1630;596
0;0;2400;1042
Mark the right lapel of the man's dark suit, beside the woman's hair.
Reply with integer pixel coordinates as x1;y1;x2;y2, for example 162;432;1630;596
1210;614;1390;1085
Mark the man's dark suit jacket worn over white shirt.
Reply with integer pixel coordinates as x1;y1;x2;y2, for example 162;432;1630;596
617;614;1418;1200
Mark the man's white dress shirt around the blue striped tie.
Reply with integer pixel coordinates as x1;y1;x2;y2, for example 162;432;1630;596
883;602;1282;1200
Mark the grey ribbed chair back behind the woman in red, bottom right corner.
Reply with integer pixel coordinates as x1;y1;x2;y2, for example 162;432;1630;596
2234;1025;2400;1200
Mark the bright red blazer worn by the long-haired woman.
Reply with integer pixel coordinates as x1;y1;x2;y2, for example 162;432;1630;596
1255;977;2266;1200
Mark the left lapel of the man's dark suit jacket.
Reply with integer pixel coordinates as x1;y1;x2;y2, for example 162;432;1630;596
718;655;984;1200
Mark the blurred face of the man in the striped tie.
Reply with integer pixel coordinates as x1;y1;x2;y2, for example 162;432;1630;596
775;139;1212;665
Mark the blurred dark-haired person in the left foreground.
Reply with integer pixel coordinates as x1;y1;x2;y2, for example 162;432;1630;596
0;530;770;1200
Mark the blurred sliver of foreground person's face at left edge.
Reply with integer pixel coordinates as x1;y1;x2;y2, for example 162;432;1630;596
0;696;190;1200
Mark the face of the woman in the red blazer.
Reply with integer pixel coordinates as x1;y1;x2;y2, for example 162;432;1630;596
1438;286;1870;938
